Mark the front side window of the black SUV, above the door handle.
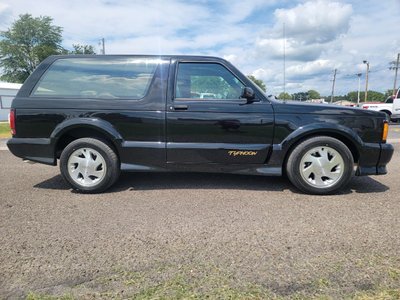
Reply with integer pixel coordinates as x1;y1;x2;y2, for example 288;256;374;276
175;63;244;100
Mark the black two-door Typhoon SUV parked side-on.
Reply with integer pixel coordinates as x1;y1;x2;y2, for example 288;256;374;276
7;55;393;194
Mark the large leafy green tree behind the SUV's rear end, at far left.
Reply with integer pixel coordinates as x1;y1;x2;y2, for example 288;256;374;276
0;14;65;83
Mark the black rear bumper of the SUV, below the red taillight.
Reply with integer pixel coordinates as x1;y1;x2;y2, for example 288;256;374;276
7;138;57;166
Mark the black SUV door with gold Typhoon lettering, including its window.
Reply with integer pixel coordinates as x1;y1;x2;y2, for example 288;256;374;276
166;60;273;166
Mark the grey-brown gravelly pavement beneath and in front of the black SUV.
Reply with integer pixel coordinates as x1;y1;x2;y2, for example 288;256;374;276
0;144;400;299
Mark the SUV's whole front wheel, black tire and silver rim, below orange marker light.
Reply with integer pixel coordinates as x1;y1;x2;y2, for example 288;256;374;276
286;136;354;195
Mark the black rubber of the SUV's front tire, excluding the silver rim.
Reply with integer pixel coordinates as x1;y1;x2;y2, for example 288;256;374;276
286;137;354;195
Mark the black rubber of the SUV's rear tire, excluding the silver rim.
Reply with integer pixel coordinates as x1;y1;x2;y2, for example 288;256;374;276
60;138;119;193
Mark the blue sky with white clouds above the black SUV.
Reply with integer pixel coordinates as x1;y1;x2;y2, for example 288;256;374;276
0;0;400;96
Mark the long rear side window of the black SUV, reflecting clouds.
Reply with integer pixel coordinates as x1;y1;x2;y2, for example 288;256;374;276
32;58;159;99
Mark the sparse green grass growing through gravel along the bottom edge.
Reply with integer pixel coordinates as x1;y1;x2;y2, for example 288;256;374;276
21;265;400;300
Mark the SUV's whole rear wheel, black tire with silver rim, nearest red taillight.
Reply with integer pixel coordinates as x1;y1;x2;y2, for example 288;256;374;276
60;138;120;193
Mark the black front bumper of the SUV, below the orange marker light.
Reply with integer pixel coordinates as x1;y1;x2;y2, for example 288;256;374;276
356;144;394;176
